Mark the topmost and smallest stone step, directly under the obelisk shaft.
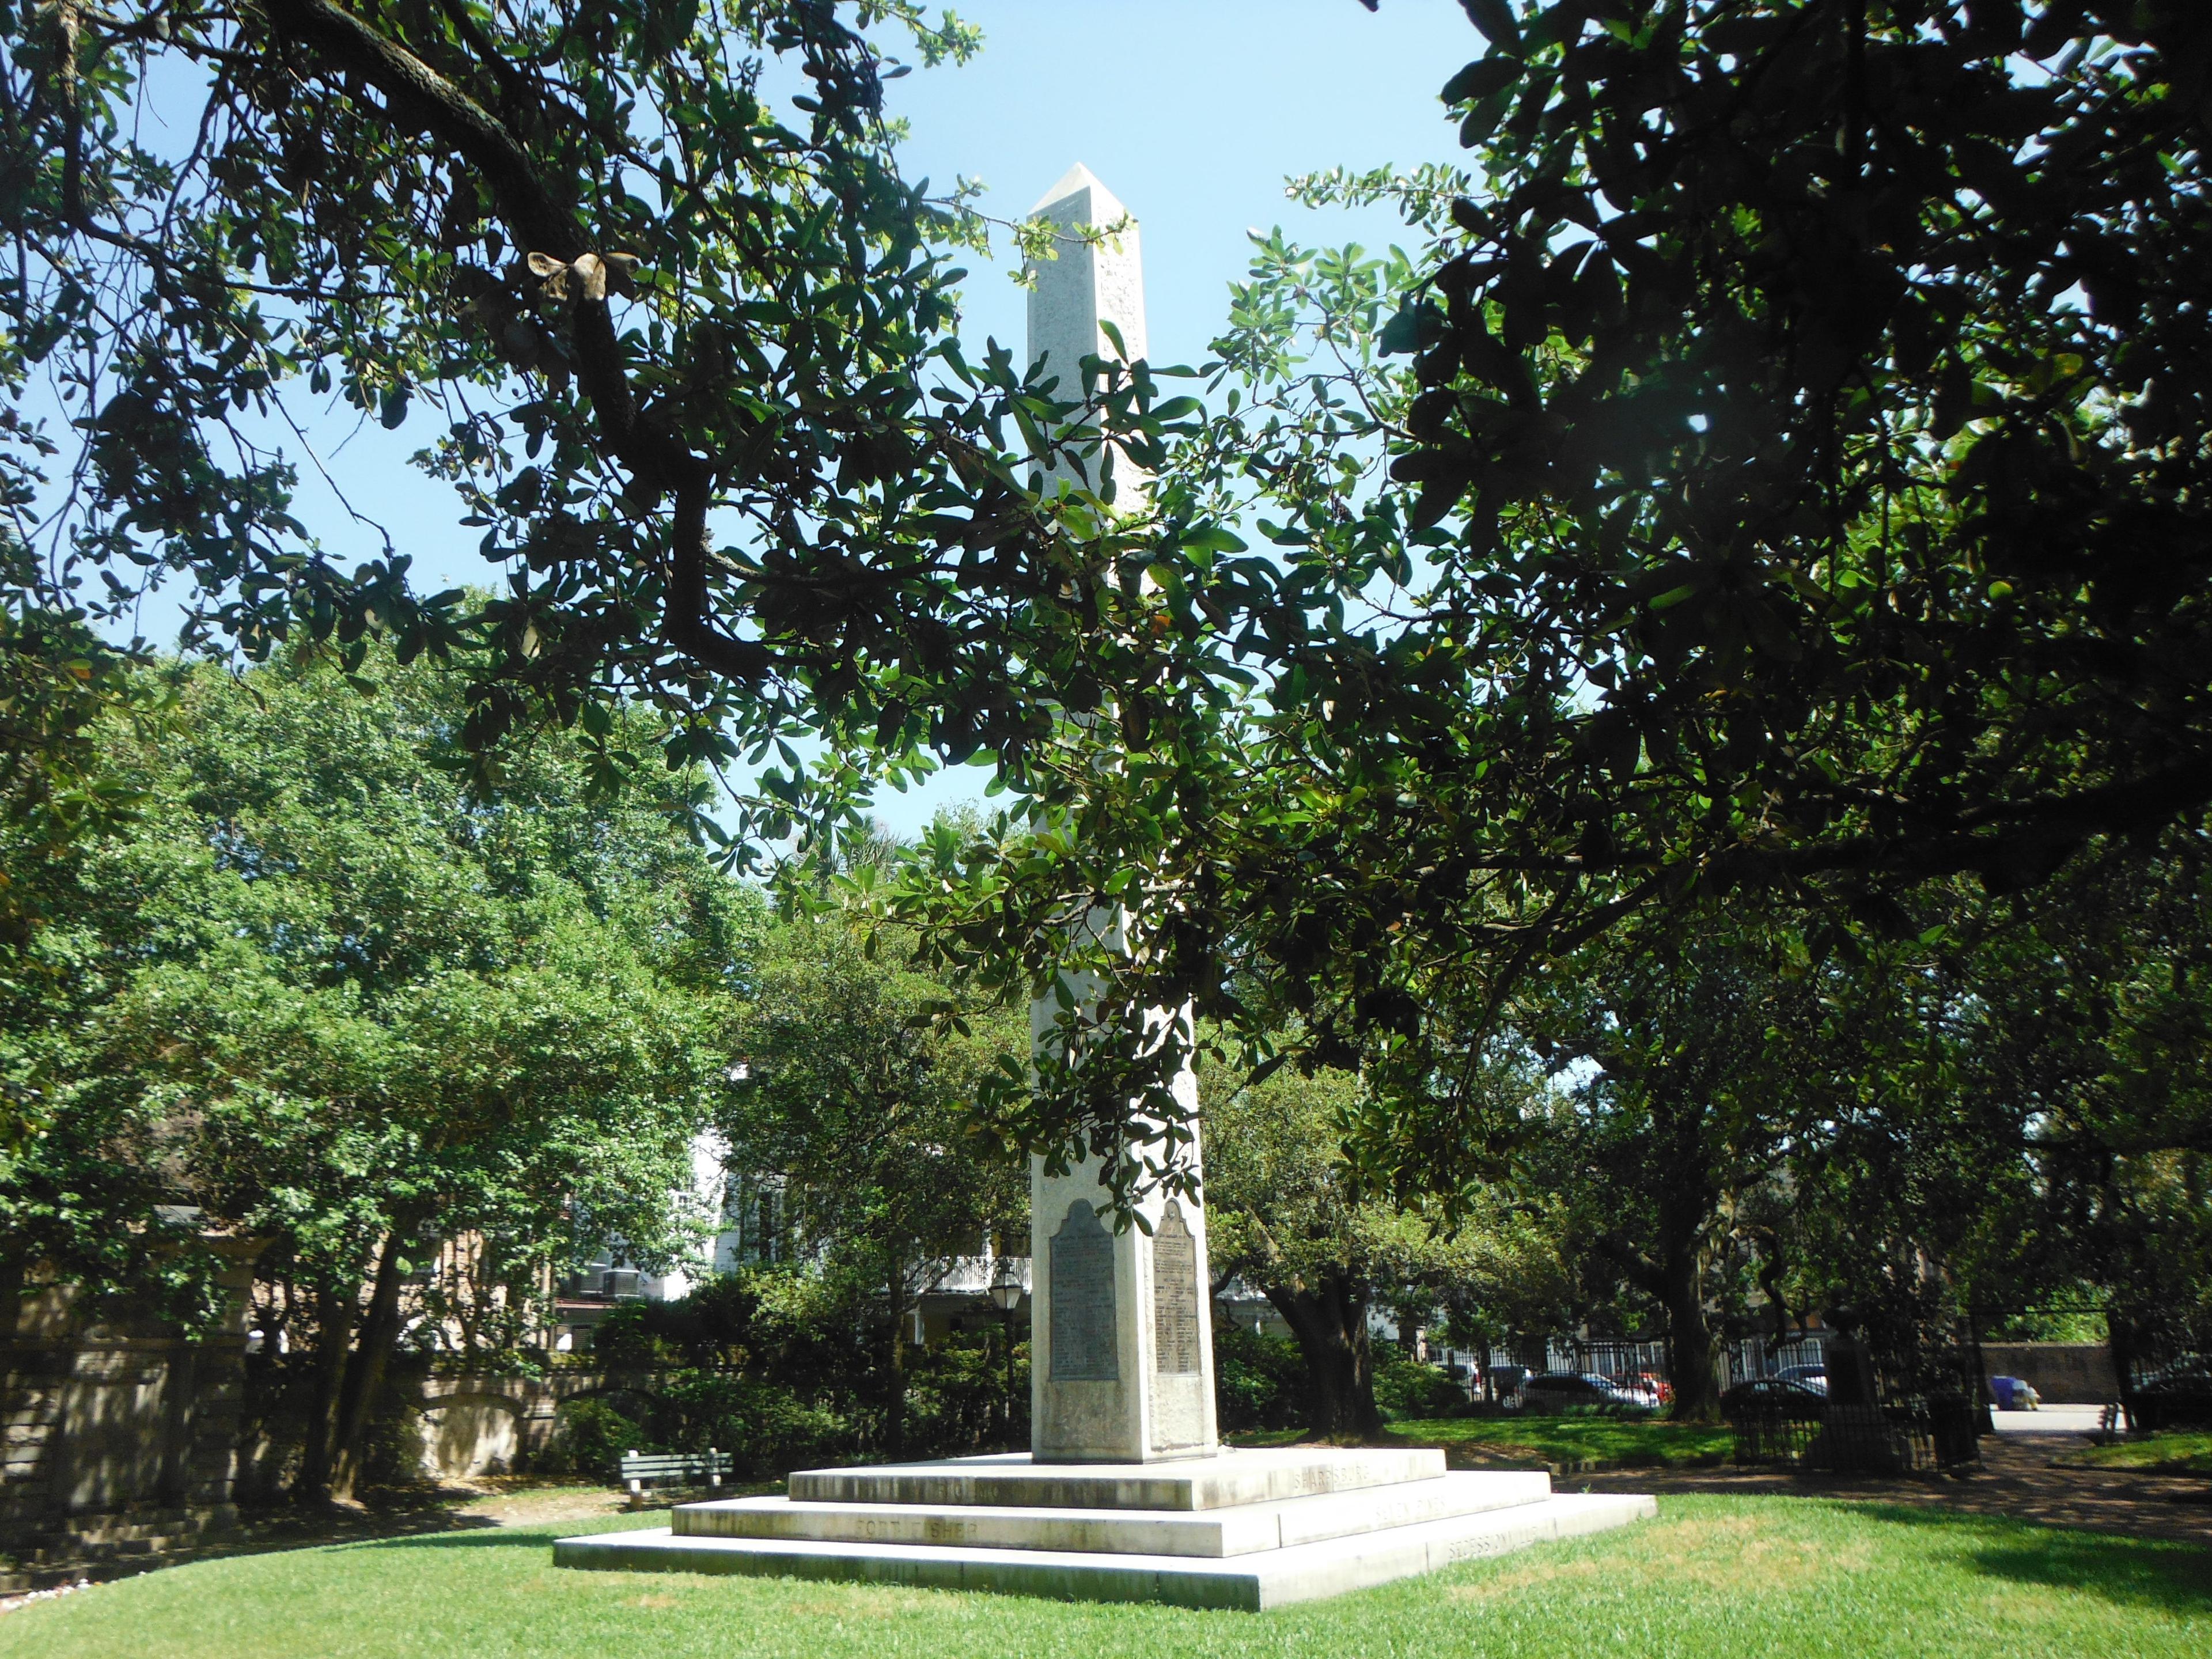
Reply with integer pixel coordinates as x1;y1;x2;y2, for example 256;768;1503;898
790;1446;1445;1509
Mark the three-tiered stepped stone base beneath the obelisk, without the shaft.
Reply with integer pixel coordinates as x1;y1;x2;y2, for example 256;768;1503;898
553;1446;1657;1611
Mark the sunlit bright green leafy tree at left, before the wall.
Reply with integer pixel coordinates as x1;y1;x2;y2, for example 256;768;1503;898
0;650;761;1488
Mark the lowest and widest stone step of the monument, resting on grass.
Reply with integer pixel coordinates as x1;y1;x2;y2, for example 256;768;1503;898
553;1493;1657;1611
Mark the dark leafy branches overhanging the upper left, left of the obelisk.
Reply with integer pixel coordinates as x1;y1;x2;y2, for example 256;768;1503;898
0;0;1194;834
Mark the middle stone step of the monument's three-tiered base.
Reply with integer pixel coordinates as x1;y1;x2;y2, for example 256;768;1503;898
671;1471;1551;1559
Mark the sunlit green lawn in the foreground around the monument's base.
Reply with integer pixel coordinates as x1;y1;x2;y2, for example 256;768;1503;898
0;1498;2212;1659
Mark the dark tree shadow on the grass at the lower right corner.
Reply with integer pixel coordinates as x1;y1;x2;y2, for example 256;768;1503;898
1854;1504;2212;1617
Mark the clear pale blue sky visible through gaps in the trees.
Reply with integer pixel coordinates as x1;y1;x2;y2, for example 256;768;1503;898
112;0;1482;832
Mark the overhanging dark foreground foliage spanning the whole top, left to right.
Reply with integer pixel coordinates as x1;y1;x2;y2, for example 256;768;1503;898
0;0;2212;1336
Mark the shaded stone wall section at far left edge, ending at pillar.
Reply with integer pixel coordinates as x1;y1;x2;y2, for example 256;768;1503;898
0;1245;255;1588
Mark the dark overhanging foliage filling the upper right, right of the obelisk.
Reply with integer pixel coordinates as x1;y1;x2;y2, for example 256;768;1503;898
893;0;2212;1188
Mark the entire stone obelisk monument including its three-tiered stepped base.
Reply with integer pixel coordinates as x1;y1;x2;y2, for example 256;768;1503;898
553;168;1654;1608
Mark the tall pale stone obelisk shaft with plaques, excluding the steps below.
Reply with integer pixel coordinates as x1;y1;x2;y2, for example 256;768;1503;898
1029;164;1219;1462
